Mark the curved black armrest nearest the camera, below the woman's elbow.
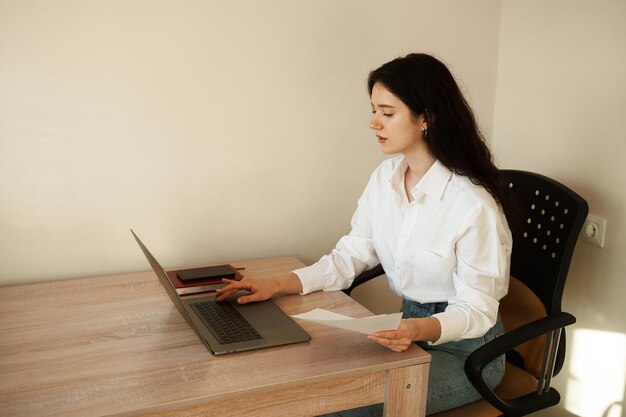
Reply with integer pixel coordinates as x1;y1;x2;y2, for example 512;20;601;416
465;313;576;416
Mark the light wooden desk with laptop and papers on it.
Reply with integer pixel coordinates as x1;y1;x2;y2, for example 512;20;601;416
0;257;430;417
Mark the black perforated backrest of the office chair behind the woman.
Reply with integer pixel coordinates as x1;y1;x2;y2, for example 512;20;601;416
501;170;588;375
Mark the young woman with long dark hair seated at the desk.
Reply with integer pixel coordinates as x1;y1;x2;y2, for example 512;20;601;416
218;54;512;416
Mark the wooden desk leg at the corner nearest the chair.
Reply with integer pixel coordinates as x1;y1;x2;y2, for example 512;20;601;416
383;364;428;417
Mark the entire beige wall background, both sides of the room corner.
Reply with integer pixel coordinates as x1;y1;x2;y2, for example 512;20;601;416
6;0;626;417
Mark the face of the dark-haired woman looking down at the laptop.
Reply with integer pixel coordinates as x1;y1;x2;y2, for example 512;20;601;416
369;83;426;155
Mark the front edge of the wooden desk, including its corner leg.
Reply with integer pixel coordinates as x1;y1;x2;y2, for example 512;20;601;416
114;364;428;417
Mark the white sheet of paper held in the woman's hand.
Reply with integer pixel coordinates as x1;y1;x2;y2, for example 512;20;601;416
291;308;402;334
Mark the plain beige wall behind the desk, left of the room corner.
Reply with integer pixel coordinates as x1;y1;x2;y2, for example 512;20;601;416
0;0;500;285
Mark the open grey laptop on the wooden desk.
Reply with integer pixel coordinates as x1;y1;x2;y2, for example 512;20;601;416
131;229;311;355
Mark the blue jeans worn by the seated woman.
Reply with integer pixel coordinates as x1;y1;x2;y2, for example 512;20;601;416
324;300;504;417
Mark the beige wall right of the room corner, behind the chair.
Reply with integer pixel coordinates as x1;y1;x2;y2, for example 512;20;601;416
493;0;626;417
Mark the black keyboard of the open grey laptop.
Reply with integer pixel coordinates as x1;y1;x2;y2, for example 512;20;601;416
191;301;261;345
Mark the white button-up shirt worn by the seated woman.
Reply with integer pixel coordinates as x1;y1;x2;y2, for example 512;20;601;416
294;156;512;344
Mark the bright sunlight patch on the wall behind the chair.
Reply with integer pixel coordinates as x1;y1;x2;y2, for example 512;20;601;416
565;329;626;417
